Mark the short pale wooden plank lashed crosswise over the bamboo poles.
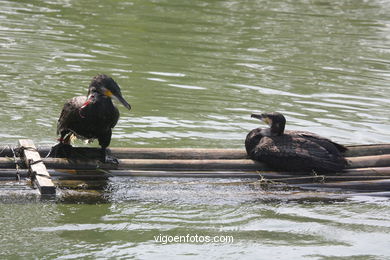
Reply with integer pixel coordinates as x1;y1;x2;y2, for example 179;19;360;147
19;139;56;195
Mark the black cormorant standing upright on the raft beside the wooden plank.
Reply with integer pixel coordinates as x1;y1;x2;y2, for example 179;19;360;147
57;75;131;163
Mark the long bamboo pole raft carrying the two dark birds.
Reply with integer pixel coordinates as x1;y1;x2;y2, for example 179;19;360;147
0;140;390;194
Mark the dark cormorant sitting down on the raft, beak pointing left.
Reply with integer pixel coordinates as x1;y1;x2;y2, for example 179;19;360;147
245;112;347;173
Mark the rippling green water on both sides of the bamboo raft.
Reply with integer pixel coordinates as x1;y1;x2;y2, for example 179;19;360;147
0;0;390;259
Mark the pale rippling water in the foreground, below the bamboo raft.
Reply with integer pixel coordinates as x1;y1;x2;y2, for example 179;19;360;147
0;178;390;258
